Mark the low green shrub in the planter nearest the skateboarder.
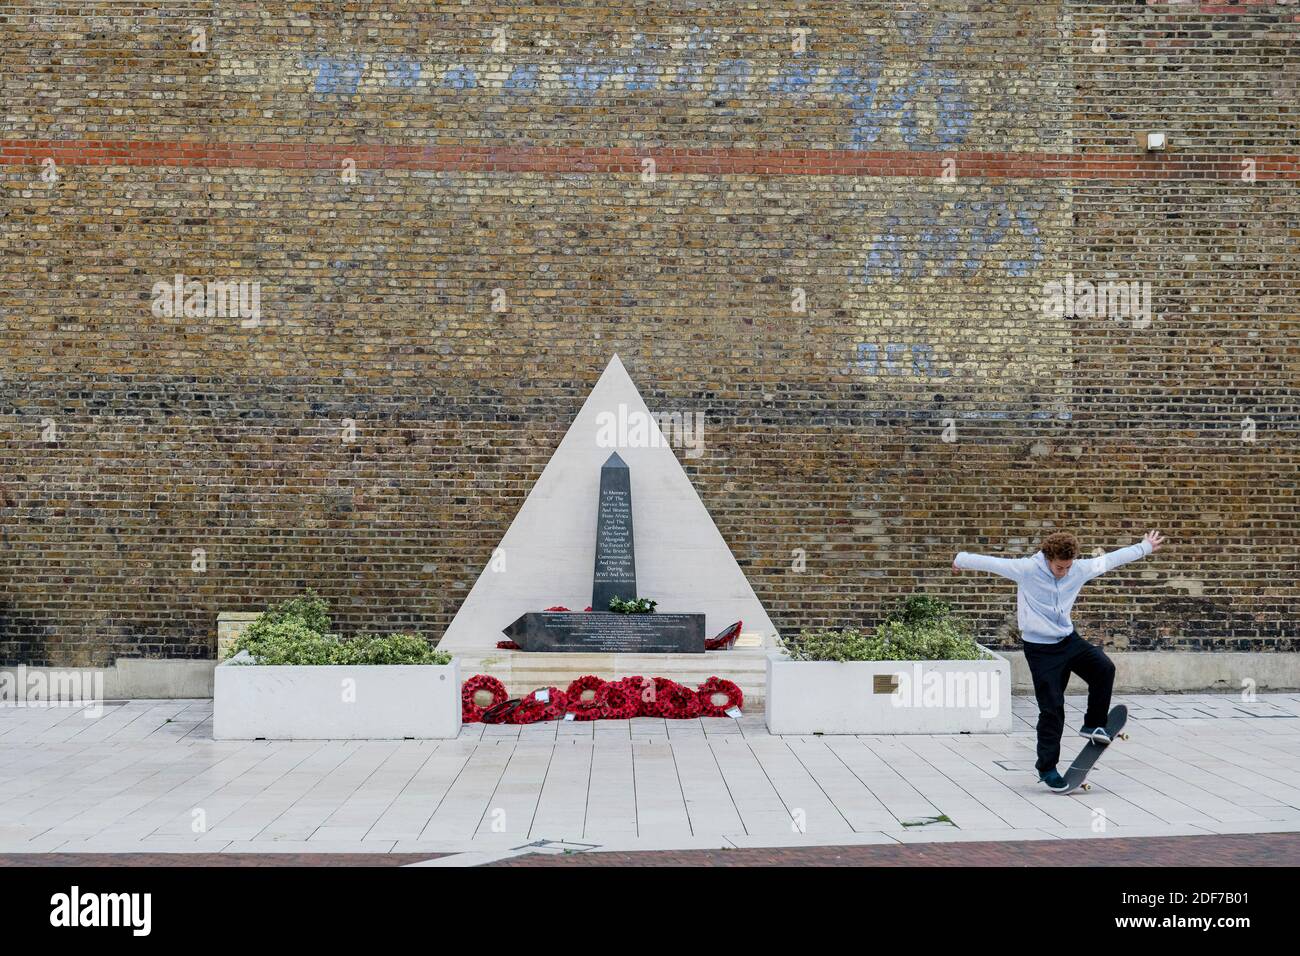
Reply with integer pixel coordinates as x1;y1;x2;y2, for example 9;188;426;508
784;620;983;661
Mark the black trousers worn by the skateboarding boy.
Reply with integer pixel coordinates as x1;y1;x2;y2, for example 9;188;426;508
1024;631;1115;774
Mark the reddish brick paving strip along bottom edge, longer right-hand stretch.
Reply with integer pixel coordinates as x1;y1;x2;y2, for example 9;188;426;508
485;834;1300;866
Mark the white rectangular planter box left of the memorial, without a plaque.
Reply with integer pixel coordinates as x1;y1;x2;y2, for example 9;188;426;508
212;661;460;740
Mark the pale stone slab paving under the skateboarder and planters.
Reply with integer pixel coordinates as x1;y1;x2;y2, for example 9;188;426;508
0;693;1300;865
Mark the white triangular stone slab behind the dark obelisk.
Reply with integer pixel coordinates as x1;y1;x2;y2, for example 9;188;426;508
438;355;776;657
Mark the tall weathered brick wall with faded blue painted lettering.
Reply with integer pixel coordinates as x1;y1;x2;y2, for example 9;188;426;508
0;0;1300;663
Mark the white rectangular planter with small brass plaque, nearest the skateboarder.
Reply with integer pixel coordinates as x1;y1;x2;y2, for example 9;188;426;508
767;646;1011;734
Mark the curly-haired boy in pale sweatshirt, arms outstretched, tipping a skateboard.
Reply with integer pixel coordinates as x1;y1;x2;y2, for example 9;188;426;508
953;531;1165;792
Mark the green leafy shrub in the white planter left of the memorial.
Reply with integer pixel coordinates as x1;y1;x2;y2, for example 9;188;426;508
230;591;451;665
